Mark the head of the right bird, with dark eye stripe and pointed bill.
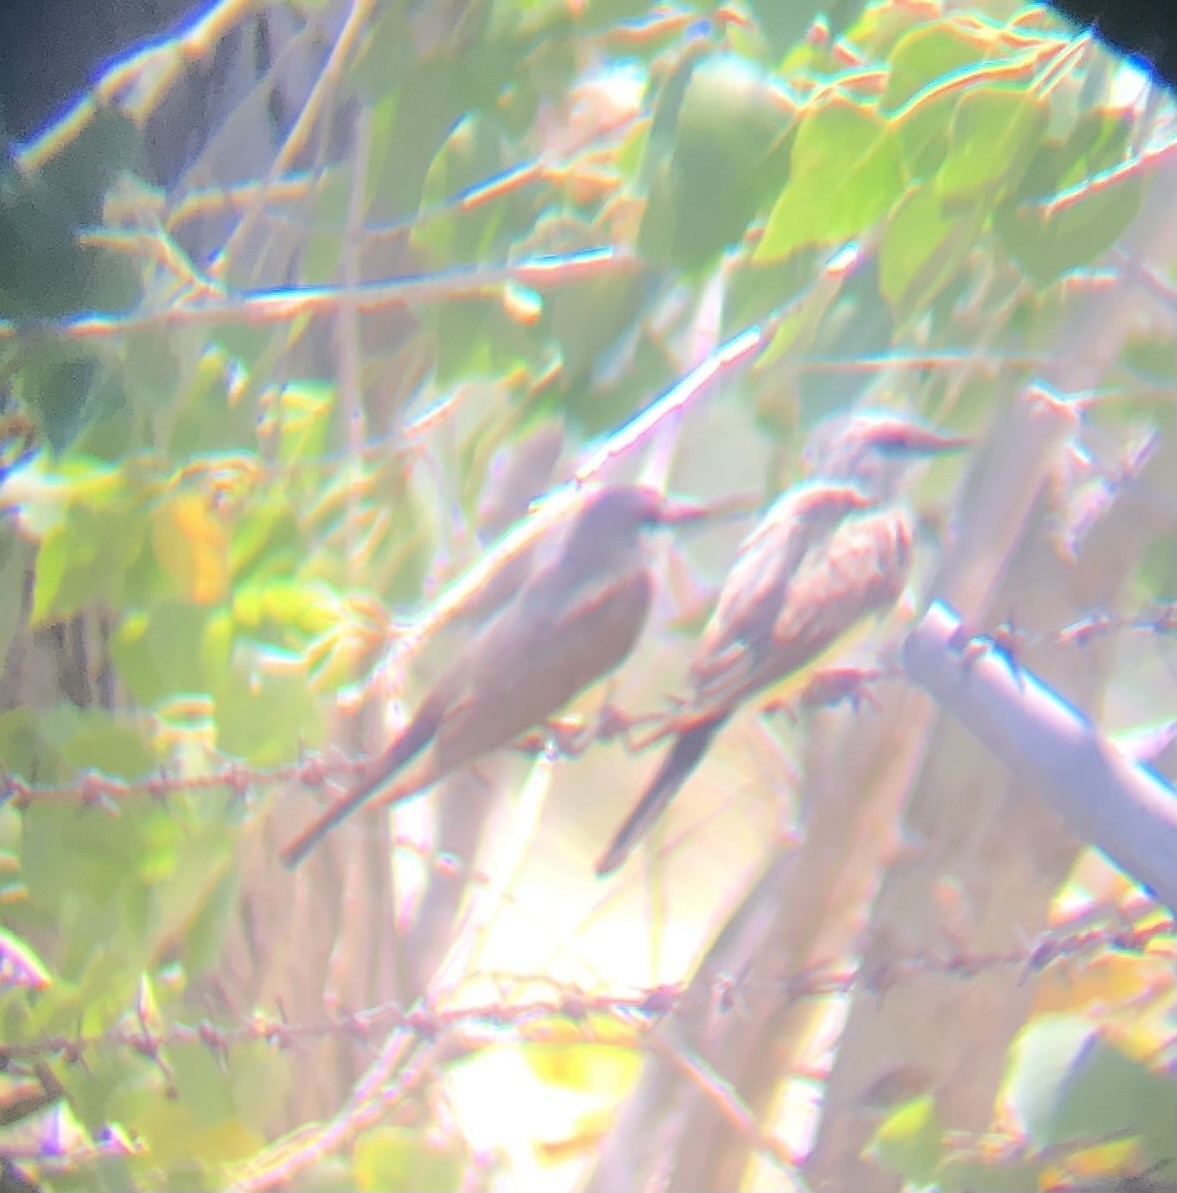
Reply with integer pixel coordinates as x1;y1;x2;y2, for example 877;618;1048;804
805;410;971;501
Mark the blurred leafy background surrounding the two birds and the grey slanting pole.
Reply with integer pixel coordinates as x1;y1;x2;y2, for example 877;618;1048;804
0;0;1177;1191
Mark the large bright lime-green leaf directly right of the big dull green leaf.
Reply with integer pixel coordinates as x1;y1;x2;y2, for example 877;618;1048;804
754;99;906;261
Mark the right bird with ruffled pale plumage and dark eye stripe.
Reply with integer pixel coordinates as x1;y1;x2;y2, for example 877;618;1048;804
595;412;968;878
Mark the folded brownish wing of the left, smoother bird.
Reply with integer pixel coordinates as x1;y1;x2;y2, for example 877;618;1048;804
434;561;651;769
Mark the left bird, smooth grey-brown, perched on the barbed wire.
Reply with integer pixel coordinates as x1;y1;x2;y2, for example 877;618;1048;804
280;484;706;867
